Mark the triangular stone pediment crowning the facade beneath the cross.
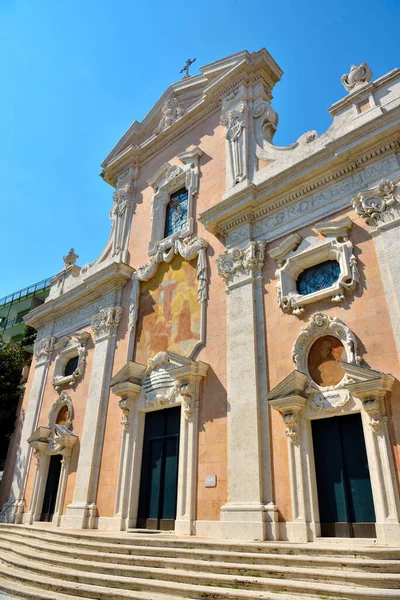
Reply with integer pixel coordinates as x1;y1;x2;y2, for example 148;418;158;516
101;48;282;170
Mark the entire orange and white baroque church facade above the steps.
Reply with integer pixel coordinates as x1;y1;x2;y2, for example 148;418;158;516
2;49;400;544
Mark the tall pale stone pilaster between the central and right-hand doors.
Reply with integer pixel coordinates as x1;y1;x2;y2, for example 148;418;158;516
217;241;267;540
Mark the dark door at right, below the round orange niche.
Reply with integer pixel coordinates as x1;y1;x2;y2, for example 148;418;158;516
312;413;376;537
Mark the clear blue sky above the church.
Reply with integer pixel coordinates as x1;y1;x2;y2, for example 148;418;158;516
0;0;400;297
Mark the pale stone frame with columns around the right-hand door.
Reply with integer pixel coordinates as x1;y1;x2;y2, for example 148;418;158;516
270;392;400;544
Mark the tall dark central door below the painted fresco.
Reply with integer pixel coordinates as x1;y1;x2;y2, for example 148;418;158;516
137;406;181;530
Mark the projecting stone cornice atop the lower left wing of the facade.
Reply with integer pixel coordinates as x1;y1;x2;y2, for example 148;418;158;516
24;263;134;330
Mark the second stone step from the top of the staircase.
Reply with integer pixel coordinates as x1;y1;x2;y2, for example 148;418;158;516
0;535;400;574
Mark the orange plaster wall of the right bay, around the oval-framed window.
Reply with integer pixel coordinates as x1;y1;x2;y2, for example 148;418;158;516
264;210;400;521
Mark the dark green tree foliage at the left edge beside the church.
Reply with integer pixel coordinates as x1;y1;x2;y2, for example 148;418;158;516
0;343;26;461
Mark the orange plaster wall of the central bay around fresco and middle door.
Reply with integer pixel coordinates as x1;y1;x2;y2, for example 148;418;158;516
97;112;227;520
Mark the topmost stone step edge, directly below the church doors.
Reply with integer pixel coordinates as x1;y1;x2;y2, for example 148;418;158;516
0;523;400;558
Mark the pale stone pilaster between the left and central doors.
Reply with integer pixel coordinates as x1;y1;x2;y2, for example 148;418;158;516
62;306;123;529
